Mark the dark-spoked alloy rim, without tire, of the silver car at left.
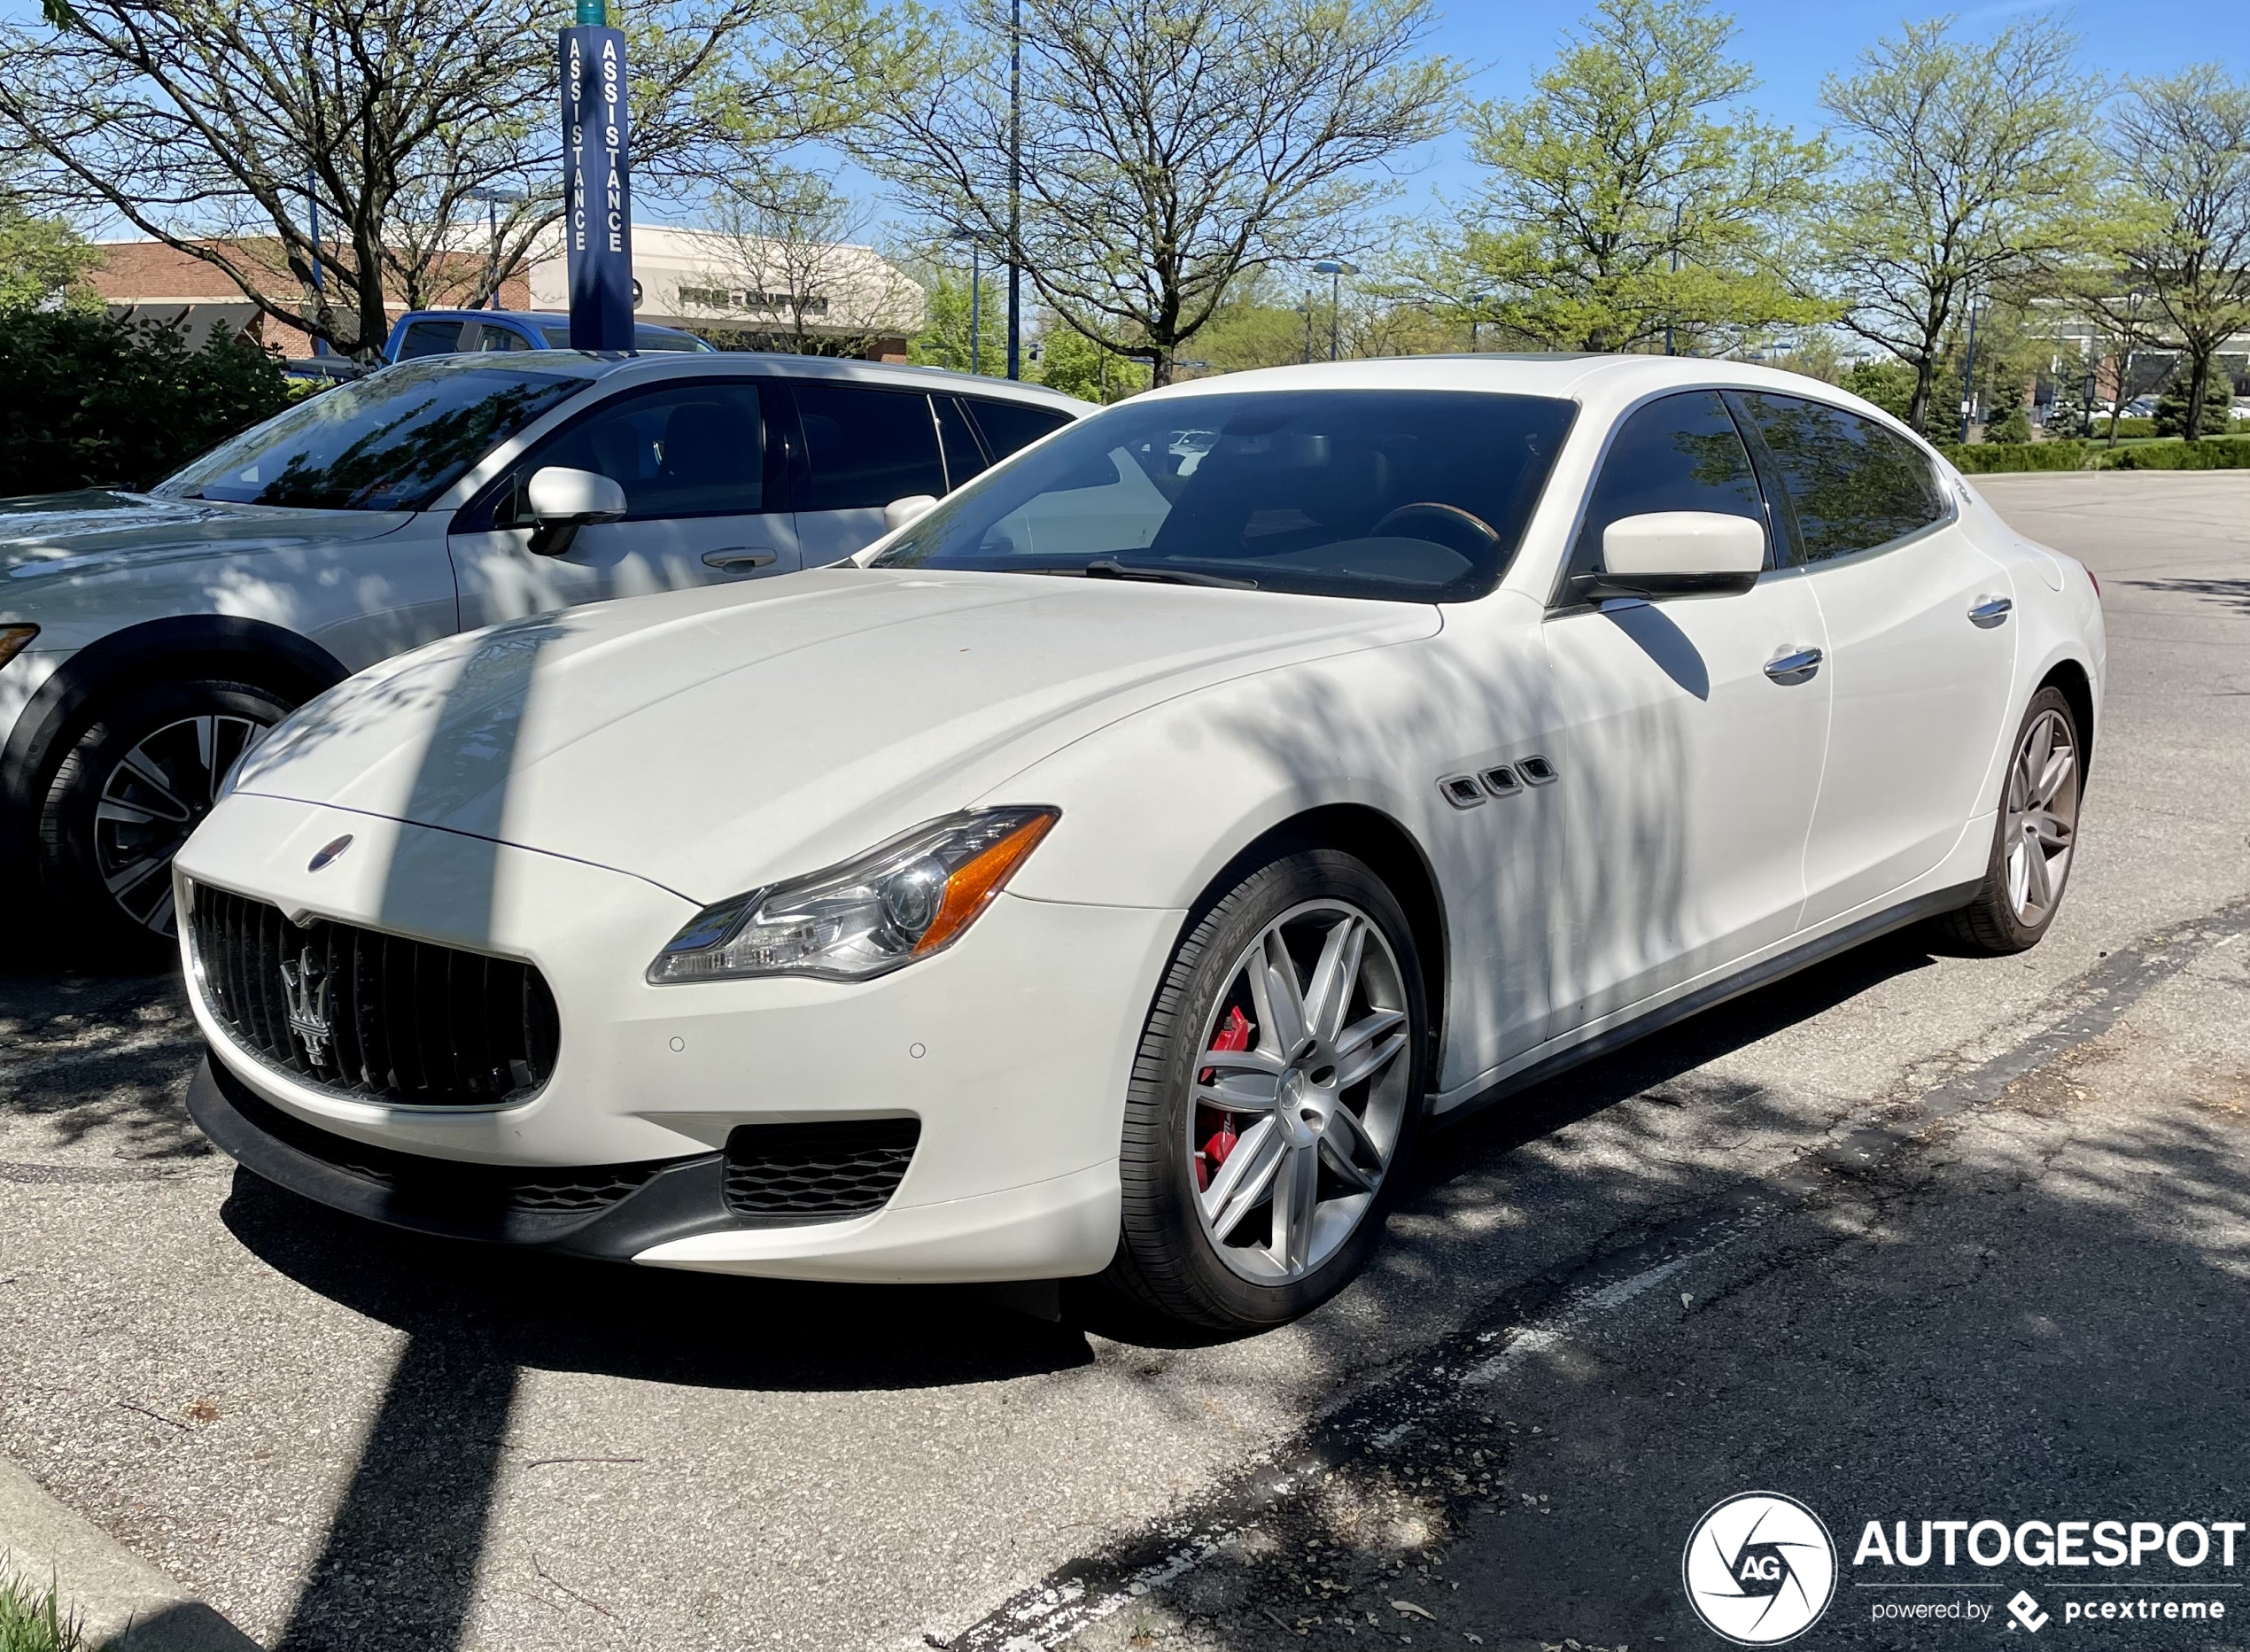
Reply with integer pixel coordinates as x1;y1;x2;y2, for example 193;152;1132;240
95;713;270;934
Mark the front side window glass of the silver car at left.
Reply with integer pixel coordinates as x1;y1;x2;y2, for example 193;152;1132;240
493;383;765;527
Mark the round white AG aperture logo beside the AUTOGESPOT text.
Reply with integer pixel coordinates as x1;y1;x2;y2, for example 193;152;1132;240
1680;1493;1836;1645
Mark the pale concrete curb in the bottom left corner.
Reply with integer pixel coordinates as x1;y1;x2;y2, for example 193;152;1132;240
0;1461;259;1652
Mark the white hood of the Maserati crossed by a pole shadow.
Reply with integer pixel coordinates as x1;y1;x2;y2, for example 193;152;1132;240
238;567;1440;903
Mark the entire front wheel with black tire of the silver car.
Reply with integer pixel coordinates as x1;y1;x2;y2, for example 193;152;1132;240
38;678;291;966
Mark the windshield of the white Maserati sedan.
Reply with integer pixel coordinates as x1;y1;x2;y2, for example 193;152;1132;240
875;390;1575;603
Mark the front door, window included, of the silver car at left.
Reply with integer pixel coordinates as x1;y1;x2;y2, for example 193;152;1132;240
447;378;801;628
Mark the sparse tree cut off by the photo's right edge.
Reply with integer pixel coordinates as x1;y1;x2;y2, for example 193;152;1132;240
2079;63;2250;441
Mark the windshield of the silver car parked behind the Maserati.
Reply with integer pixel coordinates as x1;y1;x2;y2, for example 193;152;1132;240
153;358;594;511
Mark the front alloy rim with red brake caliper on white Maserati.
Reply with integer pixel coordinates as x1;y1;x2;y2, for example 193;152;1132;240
1188;900;1413;1285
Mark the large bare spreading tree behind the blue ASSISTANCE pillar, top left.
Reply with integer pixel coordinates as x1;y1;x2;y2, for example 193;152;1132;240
0;0;912;353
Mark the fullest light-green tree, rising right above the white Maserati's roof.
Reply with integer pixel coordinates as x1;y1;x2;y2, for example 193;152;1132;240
1424;0;1827;351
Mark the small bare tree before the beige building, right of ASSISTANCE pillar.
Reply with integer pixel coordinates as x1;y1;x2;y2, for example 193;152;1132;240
679;171;922;355
